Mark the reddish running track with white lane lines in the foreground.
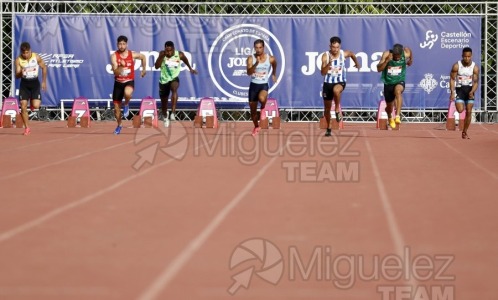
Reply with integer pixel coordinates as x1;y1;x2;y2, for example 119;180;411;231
0;122;498;300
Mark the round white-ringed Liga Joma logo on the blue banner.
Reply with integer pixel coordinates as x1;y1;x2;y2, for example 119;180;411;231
208;24;285;99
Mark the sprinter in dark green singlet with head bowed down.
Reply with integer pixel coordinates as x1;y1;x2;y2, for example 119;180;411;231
377;44;413;128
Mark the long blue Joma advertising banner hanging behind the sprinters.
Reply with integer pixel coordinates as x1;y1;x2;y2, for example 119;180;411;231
13;15;481;109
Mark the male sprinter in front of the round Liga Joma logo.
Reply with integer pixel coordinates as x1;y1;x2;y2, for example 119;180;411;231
247;39;277;136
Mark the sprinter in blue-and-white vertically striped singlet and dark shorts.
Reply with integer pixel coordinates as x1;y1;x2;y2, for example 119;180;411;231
321;36;360;136
